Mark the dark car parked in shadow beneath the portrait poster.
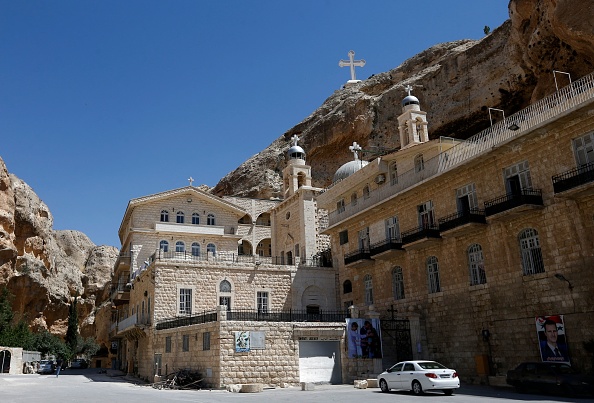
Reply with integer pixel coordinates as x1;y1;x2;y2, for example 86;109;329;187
506;362;594;396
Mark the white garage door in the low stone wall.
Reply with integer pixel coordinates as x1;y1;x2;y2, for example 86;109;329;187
299;341;342;384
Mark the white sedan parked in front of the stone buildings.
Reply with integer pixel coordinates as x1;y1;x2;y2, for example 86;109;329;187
377;360;460;396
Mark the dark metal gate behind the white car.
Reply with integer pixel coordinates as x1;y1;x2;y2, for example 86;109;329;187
380;318;413;367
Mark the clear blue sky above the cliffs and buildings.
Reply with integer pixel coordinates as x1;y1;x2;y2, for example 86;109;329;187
0;0;508;247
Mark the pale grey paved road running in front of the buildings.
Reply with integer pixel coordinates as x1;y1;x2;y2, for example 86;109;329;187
0;369;594;403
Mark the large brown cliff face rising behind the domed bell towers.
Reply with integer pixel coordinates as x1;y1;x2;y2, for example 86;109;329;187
213;0;594;198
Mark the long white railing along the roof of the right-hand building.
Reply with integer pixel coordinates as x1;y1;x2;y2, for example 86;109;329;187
326;74;594;226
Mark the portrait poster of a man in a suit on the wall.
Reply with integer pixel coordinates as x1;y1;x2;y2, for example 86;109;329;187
536;315;569;364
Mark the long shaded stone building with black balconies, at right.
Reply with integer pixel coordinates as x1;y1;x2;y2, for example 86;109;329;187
317;75;594;382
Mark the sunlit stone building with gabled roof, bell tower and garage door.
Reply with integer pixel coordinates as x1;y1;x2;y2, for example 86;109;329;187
110;139;347;387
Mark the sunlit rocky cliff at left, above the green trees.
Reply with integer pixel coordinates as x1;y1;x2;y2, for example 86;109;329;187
0;158;118;336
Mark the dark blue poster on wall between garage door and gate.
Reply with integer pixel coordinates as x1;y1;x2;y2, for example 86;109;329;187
346;318;382;358
